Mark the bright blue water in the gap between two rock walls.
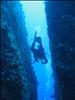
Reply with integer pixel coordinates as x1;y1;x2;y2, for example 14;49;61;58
21;1;55;100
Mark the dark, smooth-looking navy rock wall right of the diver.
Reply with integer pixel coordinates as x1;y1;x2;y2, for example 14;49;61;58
45;1;75;100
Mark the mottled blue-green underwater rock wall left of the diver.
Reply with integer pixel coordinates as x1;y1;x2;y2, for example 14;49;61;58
0;1;37;100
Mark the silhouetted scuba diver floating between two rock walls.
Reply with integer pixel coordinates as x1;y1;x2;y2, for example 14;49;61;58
31;32;48;64
